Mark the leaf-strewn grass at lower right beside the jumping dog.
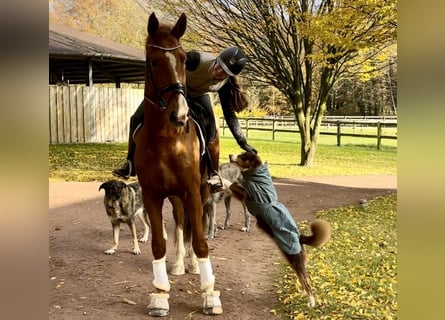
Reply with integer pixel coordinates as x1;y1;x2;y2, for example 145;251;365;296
271;194;397;320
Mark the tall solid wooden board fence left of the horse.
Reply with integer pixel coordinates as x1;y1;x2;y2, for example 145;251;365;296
49;85;144;143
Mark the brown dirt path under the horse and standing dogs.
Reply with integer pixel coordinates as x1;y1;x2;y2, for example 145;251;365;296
49;176;397;320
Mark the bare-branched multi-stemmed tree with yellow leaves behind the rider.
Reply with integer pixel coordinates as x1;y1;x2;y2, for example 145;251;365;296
162;0;397;166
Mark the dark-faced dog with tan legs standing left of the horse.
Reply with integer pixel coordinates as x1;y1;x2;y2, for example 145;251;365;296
99;180;150;254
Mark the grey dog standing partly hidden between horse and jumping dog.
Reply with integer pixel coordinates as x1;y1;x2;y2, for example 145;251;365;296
204;162;250;239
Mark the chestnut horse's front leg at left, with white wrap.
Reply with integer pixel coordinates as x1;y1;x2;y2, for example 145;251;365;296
142;192;170;317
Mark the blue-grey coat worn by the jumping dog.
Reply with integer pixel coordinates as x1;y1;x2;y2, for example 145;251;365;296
241;164;301;254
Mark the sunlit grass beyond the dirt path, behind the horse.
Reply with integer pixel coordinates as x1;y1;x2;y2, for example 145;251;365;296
49;136;397;181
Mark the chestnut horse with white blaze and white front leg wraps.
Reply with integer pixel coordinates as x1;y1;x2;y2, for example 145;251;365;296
135;13;222;316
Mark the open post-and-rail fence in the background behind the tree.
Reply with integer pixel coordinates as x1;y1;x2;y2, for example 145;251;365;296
220;116;397;150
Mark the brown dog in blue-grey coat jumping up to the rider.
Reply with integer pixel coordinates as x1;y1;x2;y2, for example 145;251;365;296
229;152;331;307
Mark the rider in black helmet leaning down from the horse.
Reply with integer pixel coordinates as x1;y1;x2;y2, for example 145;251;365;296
113;47;256;192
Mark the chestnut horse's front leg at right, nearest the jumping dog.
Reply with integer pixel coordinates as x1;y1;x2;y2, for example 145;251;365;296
184;194;223;315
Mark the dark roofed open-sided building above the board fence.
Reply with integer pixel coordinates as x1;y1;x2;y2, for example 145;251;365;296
49;24;145;86
